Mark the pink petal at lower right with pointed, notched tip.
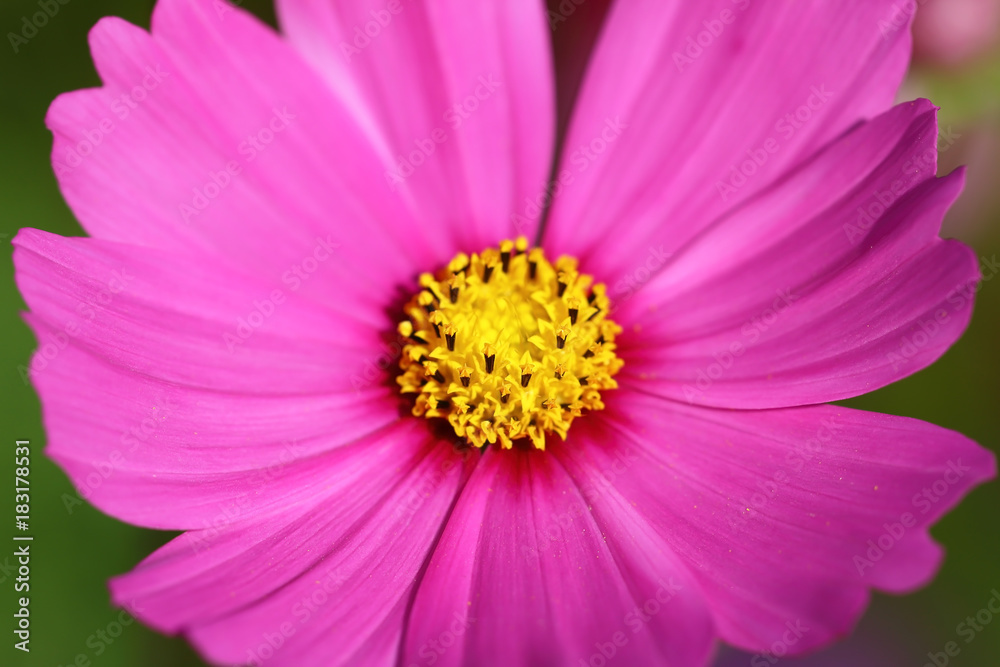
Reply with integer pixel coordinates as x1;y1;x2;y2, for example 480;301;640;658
572;388;996;653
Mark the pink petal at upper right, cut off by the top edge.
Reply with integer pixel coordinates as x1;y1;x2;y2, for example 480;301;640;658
545;0;910;282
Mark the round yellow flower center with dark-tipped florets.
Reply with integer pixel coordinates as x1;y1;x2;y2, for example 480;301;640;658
398;238;622;449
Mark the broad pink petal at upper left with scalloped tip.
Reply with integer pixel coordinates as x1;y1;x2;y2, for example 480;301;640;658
47;0;457;314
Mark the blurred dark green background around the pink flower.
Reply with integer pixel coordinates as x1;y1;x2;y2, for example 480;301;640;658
0;0;1000;667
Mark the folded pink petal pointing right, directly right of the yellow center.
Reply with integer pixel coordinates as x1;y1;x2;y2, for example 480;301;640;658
616;100;979;408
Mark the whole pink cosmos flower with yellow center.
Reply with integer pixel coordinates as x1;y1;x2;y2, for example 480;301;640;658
15;0;995;667
